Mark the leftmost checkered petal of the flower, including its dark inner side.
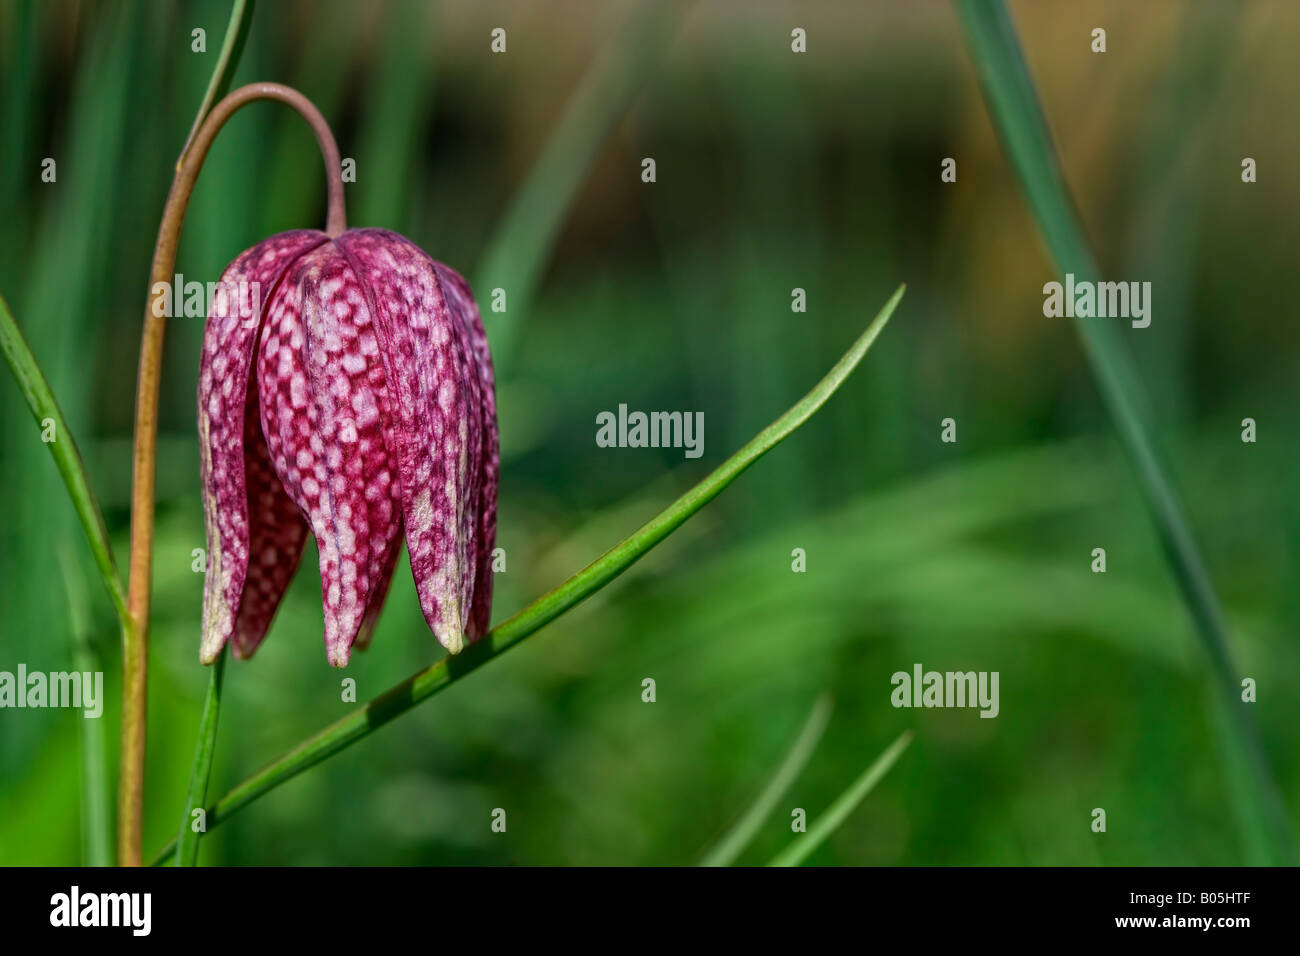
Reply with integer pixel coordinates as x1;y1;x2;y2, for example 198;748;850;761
199;230;328;663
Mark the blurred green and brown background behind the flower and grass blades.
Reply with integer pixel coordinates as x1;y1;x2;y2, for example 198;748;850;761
0;0;1300;865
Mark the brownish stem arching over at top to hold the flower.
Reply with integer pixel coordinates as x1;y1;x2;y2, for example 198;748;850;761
117;83;347;866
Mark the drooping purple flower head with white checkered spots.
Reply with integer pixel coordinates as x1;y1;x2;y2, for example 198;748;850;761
199;229;498;667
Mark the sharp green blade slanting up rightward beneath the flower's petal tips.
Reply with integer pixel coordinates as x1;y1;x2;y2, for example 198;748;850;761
149;286;906;857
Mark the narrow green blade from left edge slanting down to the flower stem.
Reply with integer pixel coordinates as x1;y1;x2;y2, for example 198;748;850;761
0;297;130;627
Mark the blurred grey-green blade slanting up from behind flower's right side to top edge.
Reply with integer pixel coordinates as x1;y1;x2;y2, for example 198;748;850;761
473;0;683;378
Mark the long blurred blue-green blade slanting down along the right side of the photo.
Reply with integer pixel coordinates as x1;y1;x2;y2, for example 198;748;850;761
957;0;1296;862
